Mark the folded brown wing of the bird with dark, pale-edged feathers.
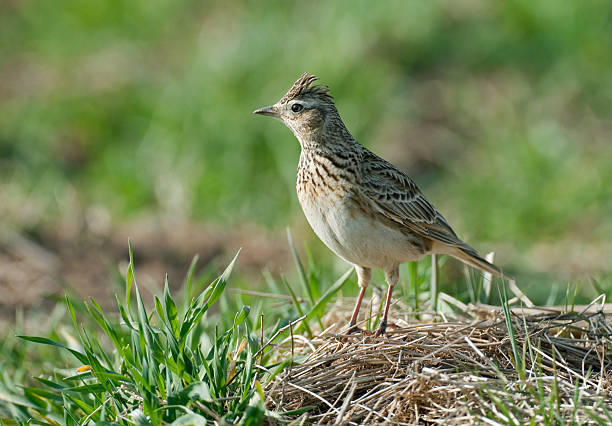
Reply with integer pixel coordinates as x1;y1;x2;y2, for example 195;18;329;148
360;148;465;247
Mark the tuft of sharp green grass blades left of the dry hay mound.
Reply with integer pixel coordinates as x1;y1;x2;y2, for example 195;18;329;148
2;248;265;425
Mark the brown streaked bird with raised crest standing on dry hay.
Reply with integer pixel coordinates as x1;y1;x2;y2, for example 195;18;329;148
253;73;502;336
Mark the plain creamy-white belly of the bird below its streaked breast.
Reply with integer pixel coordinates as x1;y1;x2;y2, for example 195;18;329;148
299;194;427;269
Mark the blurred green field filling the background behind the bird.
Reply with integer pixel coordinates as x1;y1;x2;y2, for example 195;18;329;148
0;0;612;312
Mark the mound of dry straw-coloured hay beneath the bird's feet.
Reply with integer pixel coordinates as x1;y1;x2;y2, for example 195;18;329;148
267;298;612;424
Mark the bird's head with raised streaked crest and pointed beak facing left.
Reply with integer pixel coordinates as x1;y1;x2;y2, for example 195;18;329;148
253;73;338;140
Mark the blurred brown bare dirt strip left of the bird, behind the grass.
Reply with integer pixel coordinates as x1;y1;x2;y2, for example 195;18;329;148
0;220;291;330
